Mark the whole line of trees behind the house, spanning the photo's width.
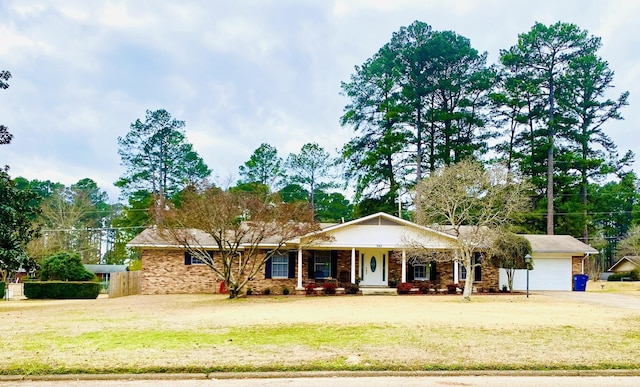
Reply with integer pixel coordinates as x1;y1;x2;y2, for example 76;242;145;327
0;21;638;274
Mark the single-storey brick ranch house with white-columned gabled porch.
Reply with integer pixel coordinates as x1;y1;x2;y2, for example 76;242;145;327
128;213;597;294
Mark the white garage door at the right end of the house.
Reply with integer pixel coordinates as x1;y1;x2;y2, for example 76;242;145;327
500;258;572;291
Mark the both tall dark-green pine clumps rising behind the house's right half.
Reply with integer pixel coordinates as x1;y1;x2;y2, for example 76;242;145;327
342;21;636;242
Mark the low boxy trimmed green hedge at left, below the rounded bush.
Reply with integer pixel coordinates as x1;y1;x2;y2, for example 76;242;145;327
24;281;100;299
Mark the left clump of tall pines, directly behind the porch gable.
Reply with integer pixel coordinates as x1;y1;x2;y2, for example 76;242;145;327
342;21;496;210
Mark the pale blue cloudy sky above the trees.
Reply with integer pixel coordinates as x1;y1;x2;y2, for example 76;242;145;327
0;0;640;202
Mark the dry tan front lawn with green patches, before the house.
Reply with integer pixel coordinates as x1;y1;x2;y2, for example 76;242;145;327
0;290;640;373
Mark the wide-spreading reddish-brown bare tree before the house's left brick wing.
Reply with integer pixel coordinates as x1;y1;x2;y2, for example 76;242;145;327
161;187;318;298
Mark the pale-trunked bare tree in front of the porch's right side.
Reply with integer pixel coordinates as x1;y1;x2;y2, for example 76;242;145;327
416;160;529;301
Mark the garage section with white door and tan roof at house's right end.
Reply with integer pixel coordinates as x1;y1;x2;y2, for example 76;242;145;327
500;234;598;291
